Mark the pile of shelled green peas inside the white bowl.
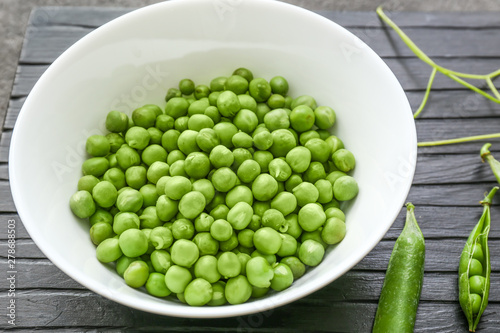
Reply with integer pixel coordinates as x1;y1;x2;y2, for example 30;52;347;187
70;68;358;306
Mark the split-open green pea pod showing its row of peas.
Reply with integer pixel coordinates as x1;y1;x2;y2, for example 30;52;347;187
458;185;498;332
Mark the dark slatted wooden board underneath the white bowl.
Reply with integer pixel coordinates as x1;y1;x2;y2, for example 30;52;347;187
0;7;500;332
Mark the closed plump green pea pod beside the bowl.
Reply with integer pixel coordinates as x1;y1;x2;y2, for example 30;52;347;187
373;203;425;333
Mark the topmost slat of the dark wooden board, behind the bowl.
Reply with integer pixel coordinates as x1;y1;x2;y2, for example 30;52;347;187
29;6;500;28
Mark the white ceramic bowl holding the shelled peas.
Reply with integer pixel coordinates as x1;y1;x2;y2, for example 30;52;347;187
9;0;416;318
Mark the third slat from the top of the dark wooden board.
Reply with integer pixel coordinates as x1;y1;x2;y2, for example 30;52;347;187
12;58;500;98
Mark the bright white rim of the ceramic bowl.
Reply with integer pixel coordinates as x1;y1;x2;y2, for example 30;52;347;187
9;0;417;318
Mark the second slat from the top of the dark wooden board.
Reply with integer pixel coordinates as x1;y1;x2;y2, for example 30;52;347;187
20;26;500;64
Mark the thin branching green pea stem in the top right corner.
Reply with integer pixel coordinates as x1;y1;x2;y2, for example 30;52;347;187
376;6;500;118
